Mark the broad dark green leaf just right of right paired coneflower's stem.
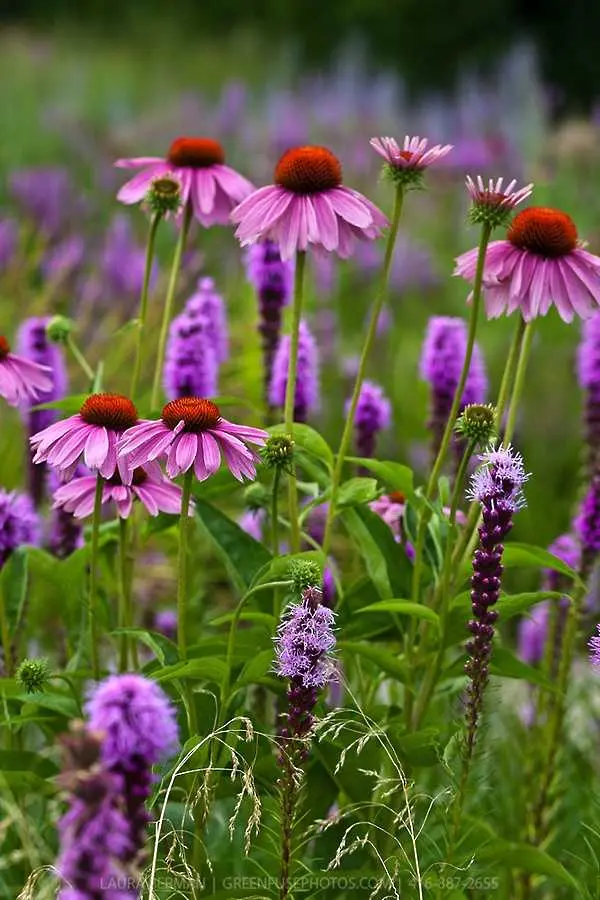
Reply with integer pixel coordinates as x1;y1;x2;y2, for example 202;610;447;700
196;499;272;594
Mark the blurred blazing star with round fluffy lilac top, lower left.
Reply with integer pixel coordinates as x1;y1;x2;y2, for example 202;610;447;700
85;674;178;862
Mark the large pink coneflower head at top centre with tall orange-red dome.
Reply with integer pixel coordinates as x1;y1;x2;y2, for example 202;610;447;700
231;146;388;260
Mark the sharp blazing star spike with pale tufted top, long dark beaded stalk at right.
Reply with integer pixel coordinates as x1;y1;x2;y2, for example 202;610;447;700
465;446;529;759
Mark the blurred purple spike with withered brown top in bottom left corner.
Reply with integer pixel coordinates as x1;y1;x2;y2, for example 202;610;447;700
56;728;139;900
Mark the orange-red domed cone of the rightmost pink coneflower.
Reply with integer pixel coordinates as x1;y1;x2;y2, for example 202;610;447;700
507;206;577;258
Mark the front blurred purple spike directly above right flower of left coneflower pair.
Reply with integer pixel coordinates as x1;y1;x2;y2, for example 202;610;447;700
163;311;219;400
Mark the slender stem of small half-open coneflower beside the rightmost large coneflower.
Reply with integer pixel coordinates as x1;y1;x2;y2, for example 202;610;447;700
412;224;492;603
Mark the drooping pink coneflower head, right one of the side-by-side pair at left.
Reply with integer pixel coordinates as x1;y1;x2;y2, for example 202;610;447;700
119;397;268;481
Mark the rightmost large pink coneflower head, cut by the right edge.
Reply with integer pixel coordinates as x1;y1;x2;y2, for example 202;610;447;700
454;206;600;322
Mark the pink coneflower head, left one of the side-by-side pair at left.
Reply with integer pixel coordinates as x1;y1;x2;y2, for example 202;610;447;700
30;394;138;483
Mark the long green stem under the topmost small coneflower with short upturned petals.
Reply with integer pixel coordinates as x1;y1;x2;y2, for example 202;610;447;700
323;185;405;558
